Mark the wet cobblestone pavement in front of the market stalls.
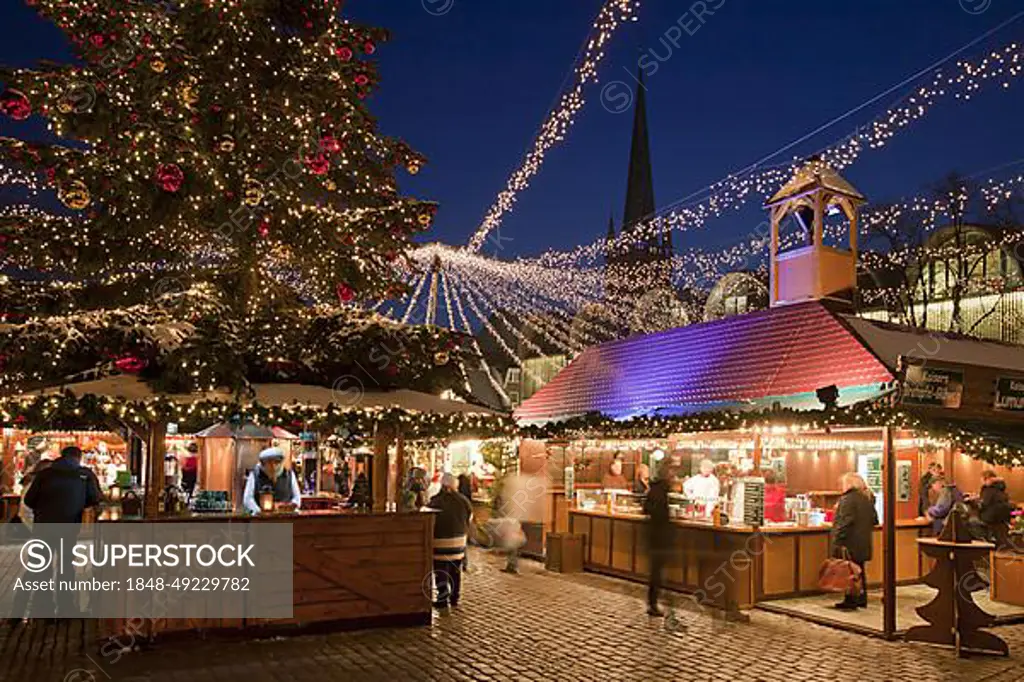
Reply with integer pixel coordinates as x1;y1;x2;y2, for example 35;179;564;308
0;552;1024;682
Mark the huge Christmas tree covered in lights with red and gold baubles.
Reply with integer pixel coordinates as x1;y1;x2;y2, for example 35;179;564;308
0;0;465;394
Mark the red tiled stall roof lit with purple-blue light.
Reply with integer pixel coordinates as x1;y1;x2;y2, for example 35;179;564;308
515;301;894;423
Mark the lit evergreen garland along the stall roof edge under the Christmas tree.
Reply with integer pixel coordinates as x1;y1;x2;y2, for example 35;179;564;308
0;392;515;440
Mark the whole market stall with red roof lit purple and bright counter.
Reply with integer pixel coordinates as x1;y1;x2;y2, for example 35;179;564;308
515;240;1024;637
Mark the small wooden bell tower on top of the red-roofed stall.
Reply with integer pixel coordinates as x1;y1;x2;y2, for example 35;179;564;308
765;158;866;306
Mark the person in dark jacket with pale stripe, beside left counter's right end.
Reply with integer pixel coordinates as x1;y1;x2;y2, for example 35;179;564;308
427;473;473;609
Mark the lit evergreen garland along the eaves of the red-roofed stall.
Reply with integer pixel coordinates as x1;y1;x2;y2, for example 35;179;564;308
519;399;1024;467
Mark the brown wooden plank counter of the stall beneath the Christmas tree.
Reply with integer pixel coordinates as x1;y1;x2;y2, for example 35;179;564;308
96;511;434;639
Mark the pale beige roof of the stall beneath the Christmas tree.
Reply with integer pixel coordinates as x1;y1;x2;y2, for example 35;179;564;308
26;375;504;415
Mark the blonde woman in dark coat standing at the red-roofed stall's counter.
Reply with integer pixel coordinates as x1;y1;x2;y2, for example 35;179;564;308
831;473;879;610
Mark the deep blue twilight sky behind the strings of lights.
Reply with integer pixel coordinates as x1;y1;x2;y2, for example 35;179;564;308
0;0;1024;257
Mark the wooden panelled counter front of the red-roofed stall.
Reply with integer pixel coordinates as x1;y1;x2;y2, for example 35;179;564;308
569;509;928;610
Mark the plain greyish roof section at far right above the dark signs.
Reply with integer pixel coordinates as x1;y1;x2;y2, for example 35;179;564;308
839;314;1024;372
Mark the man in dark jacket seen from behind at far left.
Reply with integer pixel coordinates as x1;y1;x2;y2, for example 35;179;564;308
15;445;101;617
